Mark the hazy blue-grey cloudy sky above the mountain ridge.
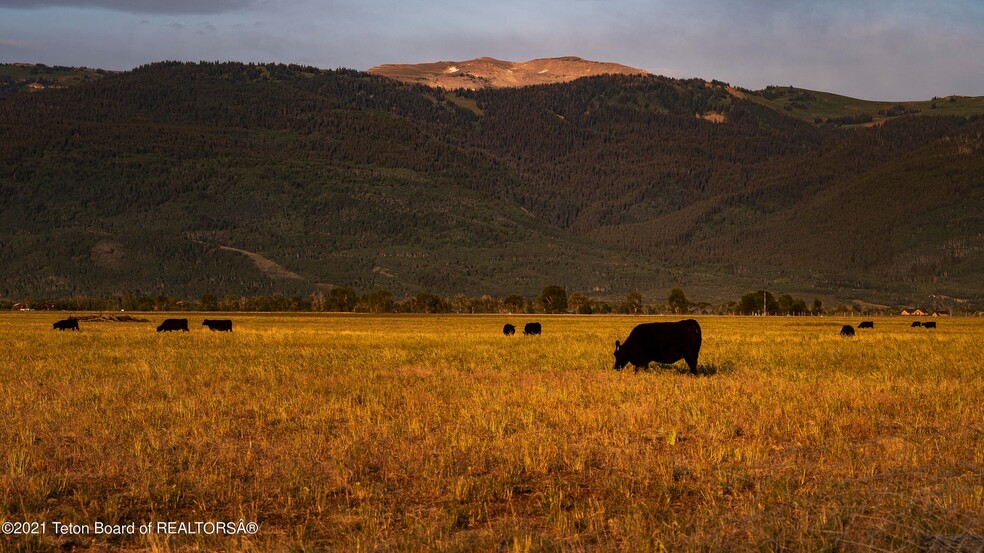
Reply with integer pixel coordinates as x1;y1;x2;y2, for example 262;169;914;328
0;0;984;101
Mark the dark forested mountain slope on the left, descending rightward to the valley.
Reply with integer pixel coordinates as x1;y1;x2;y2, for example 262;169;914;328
0;64;659;295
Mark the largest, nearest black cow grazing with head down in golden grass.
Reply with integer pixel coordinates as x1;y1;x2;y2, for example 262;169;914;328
615;319;701;374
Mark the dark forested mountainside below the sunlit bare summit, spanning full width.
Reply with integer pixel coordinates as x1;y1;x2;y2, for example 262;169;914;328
0;62;984;306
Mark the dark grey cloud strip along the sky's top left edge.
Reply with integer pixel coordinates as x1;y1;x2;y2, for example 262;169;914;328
0;0;255;15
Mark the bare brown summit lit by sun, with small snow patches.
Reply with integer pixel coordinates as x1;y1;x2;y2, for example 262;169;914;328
369;56;648;89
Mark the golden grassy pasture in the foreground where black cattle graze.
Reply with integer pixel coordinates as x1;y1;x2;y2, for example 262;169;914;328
0;313;984;551
